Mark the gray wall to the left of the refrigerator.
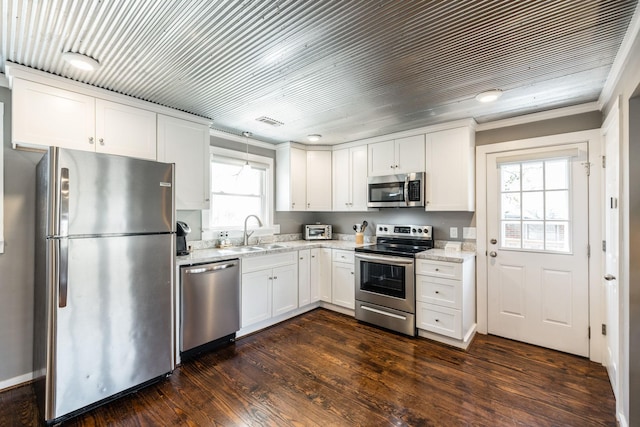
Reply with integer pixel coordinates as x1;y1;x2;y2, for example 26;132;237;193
0;88;42;382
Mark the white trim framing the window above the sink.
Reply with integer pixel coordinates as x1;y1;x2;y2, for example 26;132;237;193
202;146;280;240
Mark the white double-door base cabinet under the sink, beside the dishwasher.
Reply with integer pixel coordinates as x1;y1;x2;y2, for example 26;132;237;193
241;252;298;328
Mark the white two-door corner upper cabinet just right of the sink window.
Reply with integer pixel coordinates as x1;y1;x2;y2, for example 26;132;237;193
276;144;331;211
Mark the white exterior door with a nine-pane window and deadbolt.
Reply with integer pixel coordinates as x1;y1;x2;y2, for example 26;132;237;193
486;143;589;356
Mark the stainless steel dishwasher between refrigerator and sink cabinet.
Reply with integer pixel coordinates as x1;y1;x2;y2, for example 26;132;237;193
180;259;240;358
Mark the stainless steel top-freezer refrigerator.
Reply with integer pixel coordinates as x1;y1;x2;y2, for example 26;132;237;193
34;148;176;423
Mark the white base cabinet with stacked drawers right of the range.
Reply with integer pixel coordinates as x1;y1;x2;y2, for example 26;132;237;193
416;258;476;348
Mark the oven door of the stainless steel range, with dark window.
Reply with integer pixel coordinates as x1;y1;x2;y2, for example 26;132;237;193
355;253;416;313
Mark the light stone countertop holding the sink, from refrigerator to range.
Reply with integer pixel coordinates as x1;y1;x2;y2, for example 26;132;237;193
176;240;368;266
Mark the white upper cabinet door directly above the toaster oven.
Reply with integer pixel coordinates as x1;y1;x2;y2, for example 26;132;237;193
306;151;331;212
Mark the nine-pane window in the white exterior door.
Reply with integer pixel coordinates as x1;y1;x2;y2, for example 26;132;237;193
499;158;572;253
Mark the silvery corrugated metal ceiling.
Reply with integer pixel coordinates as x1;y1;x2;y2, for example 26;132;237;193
0;0;637;144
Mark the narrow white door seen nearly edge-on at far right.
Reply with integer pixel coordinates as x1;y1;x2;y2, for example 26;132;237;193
603;109;620;398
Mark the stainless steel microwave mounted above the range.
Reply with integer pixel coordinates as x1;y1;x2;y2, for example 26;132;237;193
367;172;425;208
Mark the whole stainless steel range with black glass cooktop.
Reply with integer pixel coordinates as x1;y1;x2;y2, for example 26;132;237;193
355;224;433;336
